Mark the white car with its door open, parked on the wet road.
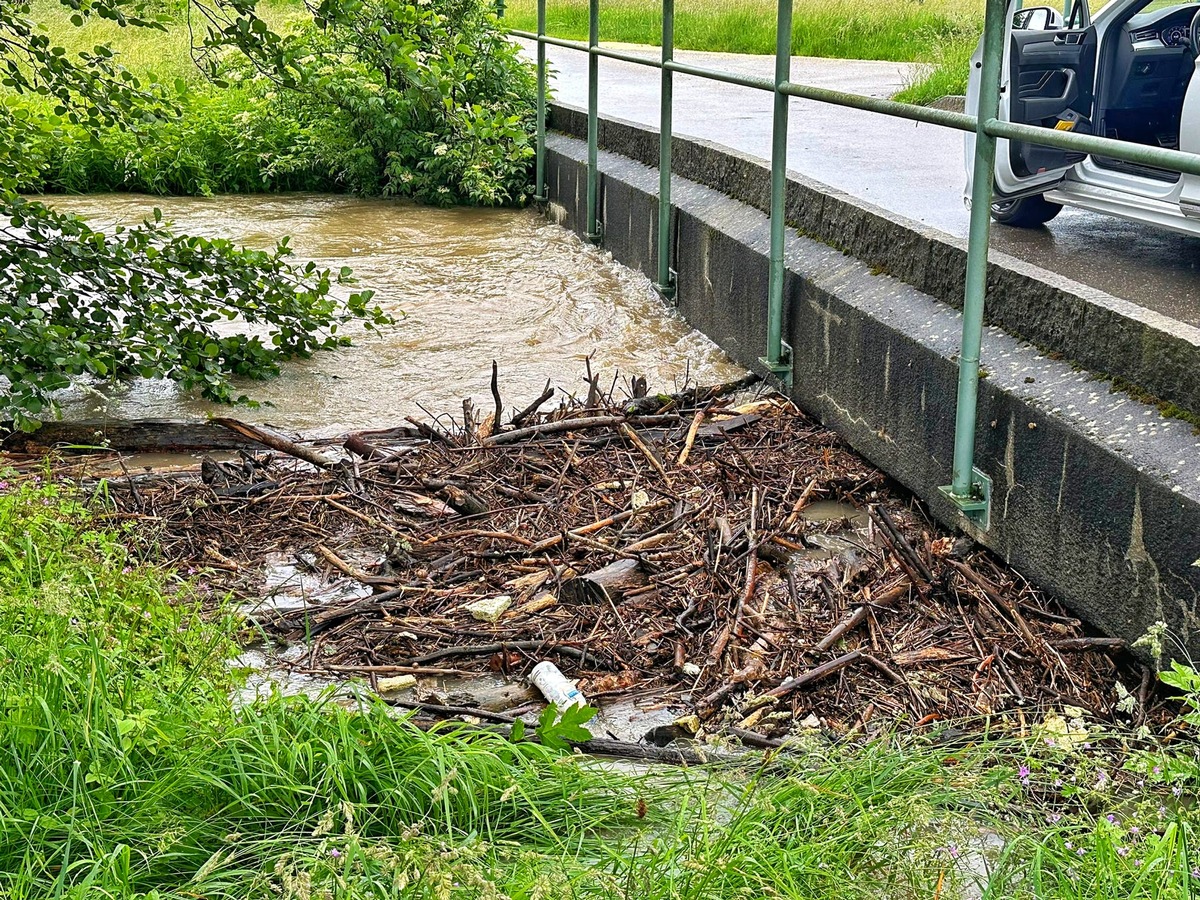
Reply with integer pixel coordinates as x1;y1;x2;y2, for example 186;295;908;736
966;0;1200;235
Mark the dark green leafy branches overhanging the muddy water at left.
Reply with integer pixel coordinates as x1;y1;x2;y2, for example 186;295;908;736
0;194;386;427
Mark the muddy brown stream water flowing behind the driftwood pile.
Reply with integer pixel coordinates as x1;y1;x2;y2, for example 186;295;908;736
50;194;742;433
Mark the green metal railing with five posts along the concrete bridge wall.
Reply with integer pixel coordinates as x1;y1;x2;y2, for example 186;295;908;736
511;0;1200;529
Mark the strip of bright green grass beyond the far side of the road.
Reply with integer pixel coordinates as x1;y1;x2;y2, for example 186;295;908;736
505;0;983;102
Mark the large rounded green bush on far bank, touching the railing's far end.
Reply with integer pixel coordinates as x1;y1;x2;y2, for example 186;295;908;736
206;0;535;205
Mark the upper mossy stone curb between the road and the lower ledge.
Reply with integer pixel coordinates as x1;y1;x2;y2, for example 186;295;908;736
552;104;1200;422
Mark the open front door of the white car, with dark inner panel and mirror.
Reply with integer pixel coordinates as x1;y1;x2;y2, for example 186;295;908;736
966;0;1097;198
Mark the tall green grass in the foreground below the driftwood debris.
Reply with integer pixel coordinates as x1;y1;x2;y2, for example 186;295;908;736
0;473;1200;900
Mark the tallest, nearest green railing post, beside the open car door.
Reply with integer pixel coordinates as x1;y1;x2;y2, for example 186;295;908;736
942;0;1007;529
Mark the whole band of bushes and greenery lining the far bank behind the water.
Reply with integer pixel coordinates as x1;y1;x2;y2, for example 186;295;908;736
8;0;535;205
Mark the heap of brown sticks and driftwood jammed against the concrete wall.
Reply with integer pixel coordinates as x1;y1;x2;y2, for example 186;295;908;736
25;379;1153;740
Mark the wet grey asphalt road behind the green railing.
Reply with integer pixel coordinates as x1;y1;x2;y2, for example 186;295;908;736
526;43;1200;326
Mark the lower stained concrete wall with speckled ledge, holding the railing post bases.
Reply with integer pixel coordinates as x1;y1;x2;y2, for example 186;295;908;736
547;134;1200;652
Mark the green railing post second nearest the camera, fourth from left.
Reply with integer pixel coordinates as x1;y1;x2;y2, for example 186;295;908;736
760;0;792;383
